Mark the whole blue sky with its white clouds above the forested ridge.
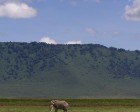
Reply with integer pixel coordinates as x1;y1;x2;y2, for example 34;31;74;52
0;0;140;50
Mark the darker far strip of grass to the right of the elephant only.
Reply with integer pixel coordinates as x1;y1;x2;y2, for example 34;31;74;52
67;99;140;106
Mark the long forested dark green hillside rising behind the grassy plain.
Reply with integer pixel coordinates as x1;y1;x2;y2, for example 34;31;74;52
0;42;140;98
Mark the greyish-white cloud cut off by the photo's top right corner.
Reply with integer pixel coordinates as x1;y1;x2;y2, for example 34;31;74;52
124;0;140;21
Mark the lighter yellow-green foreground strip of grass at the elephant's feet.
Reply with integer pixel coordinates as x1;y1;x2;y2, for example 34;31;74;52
0;106;140;112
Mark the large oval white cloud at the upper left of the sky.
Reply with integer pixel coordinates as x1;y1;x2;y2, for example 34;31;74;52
0;0;37;18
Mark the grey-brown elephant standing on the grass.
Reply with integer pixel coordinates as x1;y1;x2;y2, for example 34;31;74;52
50;100;69;112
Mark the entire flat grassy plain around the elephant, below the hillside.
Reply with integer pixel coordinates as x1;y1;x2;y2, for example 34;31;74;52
0;99;140;112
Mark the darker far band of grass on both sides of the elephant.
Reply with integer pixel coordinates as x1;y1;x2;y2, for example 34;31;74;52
0;99;140;107
